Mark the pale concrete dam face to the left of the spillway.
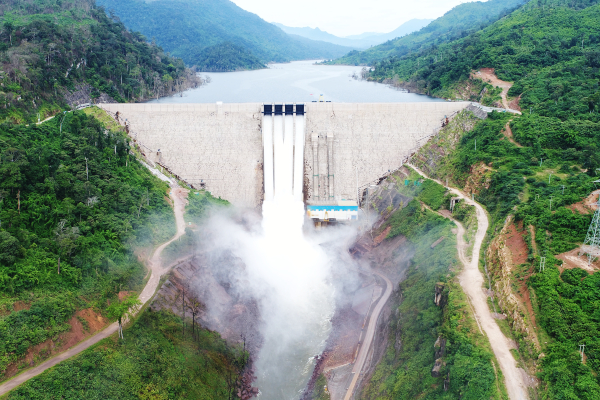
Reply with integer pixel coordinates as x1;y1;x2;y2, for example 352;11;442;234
100;103;263;207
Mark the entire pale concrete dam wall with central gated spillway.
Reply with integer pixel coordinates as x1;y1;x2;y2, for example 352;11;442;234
100;102;471;208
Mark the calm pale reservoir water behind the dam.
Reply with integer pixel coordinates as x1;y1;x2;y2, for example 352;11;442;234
150;61;443;103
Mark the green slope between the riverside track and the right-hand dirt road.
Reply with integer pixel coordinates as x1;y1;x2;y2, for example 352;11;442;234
360;175;503;400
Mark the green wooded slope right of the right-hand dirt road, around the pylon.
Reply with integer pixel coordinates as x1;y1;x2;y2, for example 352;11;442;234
406;106;600;399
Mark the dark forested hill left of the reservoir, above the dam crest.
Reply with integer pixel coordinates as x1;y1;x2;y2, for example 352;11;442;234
0;0;200;123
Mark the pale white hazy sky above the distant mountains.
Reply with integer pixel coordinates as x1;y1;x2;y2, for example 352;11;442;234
232;0;478;36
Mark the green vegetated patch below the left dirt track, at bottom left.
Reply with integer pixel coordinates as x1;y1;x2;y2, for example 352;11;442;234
3;311;248;400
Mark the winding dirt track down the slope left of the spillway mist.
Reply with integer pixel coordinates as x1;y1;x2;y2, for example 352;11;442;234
0;187;188;396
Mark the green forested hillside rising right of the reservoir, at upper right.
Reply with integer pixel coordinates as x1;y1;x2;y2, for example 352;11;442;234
372;0;600;120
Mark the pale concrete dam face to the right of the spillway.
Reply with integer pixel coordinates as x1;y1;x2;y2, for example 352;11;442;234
304;102;470;203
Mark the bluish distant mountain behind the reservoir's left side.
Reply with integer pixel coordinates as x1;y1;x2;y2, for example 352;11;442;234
97;0;352;69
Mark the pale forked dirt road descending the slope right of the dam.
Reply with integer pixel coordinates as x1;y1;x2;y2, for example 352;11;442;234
408;164;529;400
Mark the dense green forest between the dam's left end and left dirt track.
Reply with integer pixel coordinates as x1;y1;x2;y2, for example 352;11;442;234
0;111;175;378
